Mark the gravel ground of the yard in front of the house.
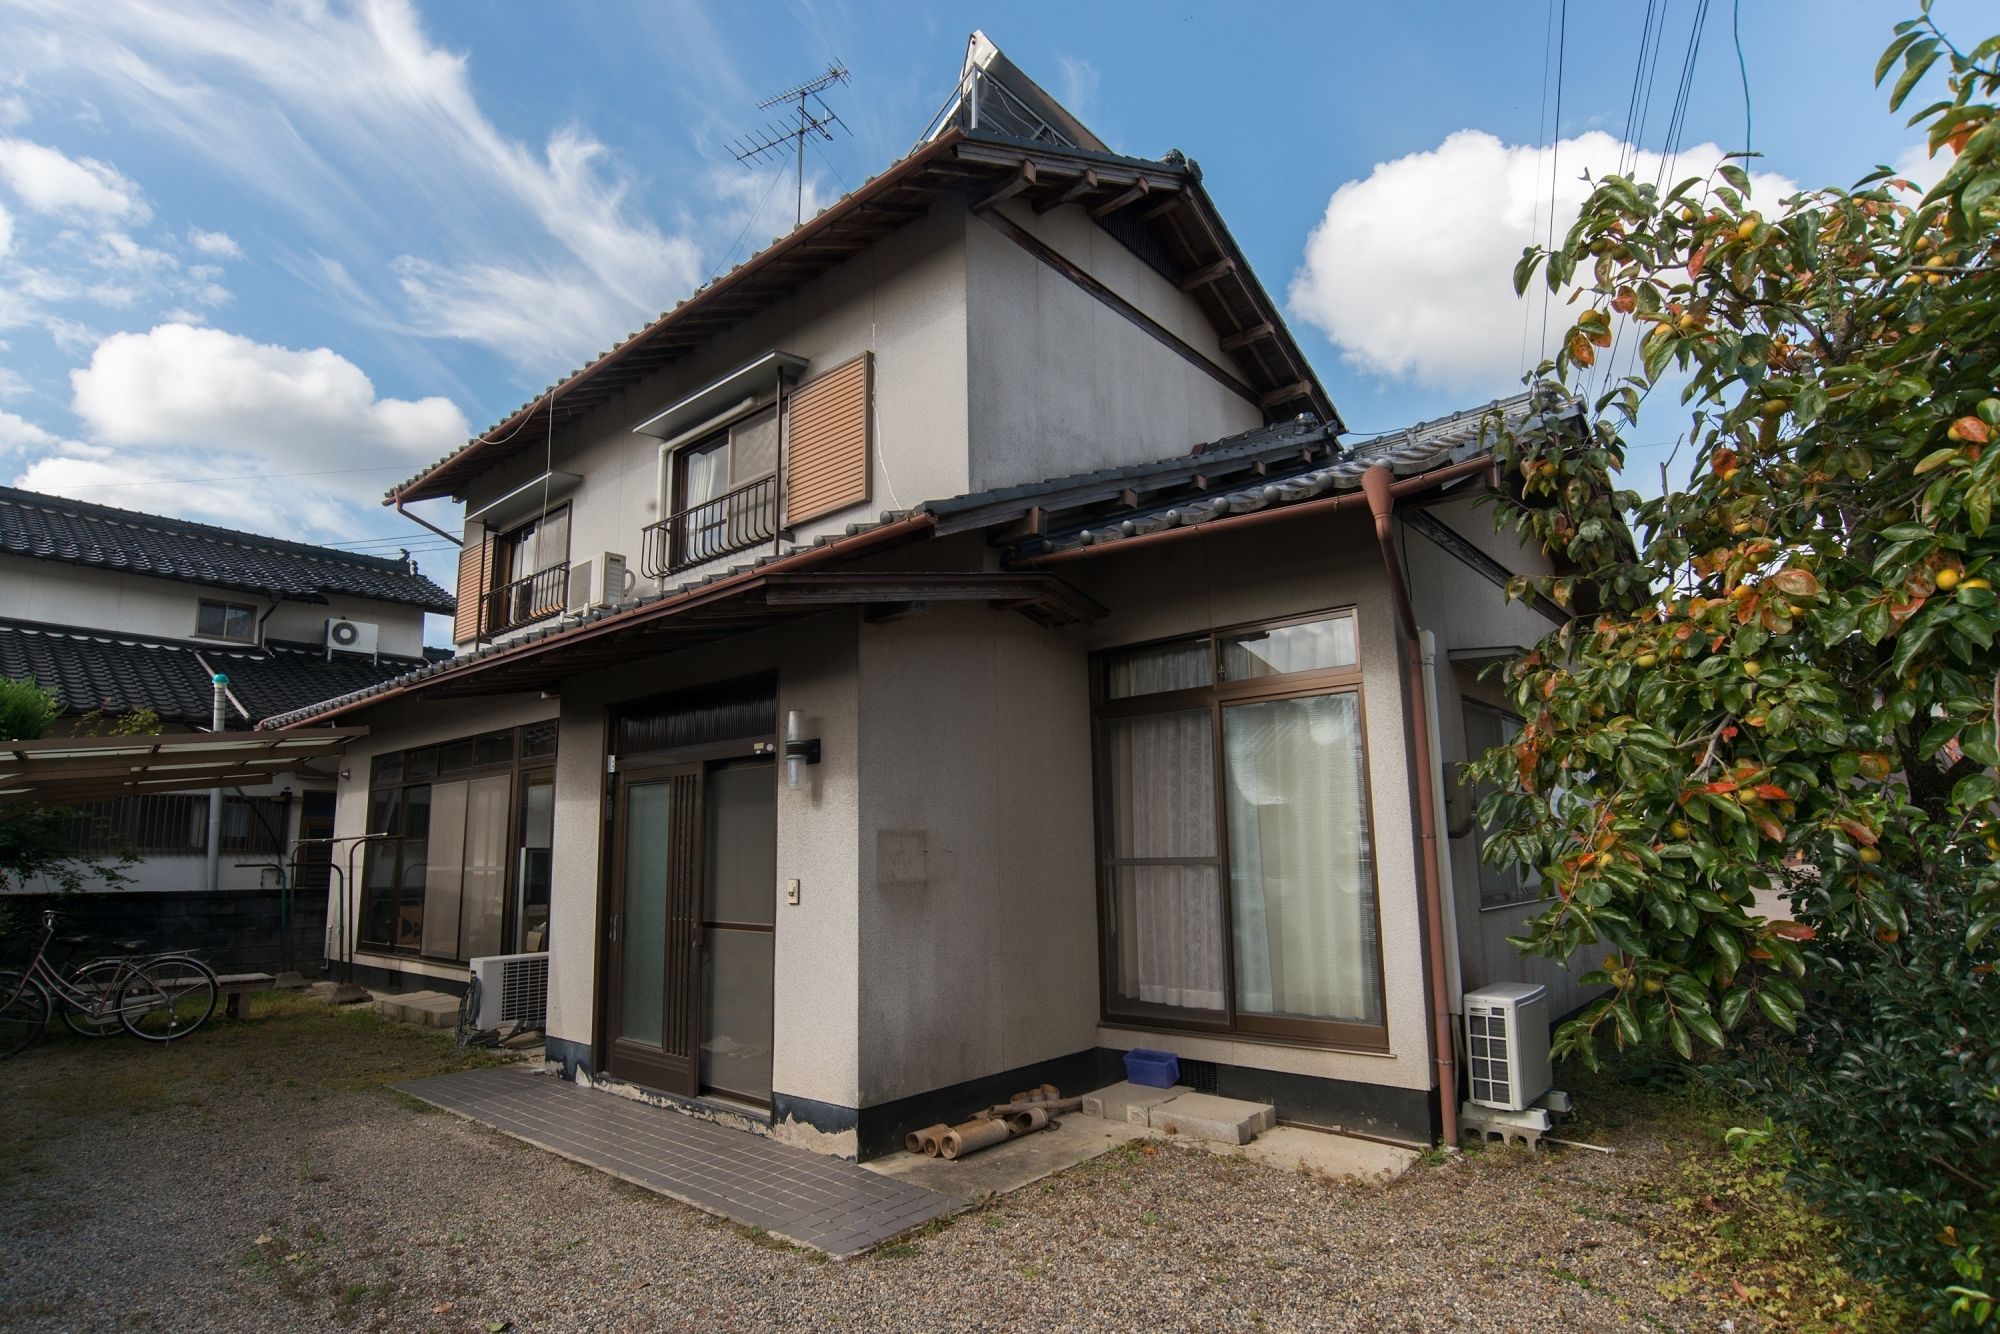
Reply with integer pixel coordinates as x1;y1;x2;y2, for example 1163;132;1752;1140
0;1000;1832;1332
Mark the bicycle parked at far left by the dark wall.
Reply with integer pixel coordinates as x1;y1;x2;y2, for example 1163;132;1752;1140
0;910;220;1058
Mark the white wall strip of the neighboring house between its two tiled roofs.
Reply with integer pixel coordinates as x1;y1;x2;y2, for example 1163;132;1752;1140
0;556;424;658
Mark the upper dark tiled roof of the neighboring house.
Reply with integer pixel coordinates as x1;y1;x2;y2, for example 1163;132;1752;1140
0;486;452;614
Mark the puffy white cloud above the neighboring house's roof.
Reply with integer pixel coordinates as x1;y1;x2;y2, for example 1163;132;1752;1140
70;324;472;462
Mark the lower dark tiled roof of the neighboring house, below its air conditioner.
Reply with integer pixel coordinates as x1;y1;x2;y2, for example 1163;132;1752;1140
0;620;446;726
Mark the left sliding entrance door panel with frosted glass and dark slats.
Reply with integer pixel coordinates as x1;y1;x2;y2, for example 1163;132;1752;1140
604;764;702;1096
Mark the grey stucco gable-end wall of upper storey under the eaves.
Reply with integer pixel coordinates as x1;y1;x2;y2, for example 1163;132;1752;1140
966;202;1264;490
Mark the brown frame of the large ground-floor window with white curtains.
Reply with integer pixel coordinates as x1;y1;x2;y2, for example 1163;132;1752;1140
1090;606;1388;1054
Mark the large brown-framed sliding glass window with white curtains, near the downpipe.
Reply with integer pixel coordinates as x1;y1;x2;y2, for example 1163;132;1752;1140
1096;612;1386;1048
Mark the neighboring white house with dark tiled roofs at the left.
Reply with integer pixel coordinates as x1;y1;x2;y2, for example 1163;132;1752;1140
0;488;452;968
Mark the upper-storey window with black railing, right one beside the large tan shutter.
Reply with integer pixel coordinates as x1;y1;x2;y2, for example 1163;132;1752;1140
648;404;778;570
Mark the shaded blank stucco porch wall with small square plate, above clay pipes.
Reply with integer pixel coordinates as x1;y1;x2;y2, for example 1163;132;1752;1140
844;606;1098;1106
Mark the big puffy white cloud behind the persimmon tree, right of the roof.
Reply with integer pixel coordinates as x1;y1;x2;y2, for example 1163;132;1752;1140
1290;130;1796;394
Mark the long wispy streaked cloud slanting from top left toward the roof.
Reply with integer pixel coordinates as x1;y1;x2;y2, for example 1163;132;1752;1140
0;0;728;374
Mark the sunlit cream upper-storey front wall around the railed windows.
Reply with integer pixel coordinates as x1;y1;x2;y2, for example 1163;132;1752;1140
468;202;968;616
